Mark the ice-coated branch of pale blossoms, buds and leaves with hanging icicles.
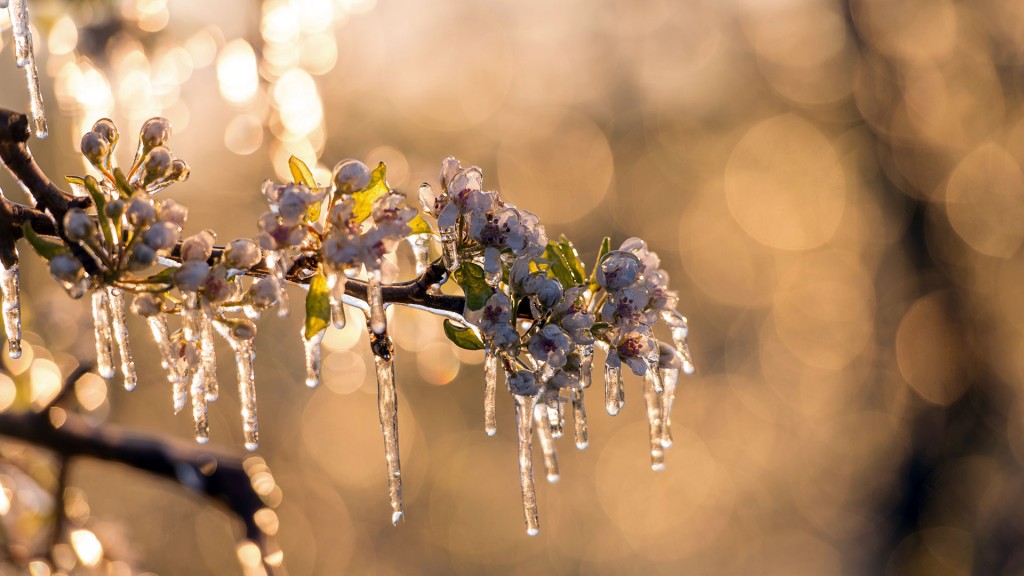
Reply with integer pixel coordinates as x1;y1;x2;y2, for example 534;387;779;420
0;118;693;534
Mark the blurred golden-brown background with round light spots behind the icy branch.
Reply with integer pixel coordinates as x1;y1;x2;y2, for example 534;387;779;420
0;0;1024;576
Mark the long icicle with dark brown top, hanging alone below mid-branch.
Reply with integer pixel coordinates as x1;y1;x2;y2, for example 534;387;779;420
370;330;402;524
